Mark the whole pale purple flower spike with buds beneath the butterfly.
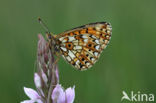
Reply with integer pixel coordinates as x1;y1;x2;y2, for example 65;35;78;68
21;34;75;103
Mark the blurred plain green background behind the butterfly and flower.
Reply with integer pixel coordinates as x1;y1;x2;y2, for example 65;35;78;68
0;0;156;103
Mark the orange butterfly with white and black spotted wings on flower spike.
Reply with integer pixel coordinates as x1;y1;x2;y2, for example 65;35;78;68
38;18;112;71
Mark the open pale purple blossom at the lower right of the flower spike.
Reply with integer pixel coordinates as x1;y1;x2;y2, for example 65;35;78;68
51;84;75;103
